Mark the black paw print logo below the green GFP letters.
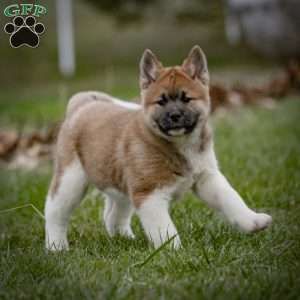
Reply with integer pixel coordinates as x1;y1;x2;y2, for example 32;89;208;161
4;16;45;48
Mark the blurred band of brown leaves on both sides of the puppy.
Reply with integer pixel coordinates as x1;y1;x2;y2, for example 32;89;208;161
0;62;300;169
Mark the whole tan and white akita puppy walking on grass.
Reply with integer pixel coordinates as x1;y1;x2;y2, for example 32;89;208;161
45;46;272;250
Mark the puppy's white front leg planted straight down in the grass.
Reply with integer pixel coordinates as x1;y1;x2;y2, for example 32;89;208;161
137;192;181;249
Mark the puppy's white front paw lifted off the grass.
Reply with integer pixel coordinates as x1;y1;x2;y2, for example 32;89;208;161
237;213;272;233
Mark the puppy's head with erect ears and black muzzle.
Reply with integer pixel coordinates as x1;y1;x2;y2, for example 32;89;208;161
140;46;210;139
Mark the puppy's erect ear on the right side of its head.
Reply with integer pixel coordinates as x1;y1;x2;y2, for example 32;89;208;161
182;45;209;84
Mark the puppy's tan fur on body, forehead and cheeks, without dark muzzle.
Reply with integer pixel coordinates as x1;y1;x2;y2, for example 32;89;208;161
51;48;210;207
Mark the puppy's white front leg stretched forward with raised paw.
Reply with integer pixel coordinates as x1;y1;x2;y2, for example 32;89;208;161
196;170;272;232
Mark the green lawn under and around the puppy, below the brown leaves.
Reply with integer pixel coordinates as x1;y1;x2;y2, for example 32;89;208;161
0;99;300;300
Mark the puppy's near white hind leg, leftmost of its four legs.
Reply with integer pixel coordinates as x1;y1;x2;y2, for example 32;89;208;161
45;159;87;251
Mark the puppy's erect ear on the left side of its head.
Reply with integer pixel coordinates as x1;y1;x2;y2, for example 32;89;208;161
140;49;162;89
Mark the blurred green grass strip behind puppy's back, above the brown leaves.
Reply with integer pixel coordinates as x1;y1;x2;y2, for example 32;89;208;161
0;73;139;129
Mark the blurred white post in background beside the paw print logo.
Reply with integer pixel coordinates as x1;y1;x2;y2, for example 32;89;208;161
56;0;75;76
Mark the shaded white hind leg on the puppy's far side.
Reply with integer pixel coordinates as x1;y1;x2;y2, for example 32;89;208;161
103;191;134;238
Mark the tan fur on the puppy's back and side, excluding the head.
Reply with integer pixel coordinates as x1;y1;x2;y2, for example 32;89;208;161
52;102;192;206
